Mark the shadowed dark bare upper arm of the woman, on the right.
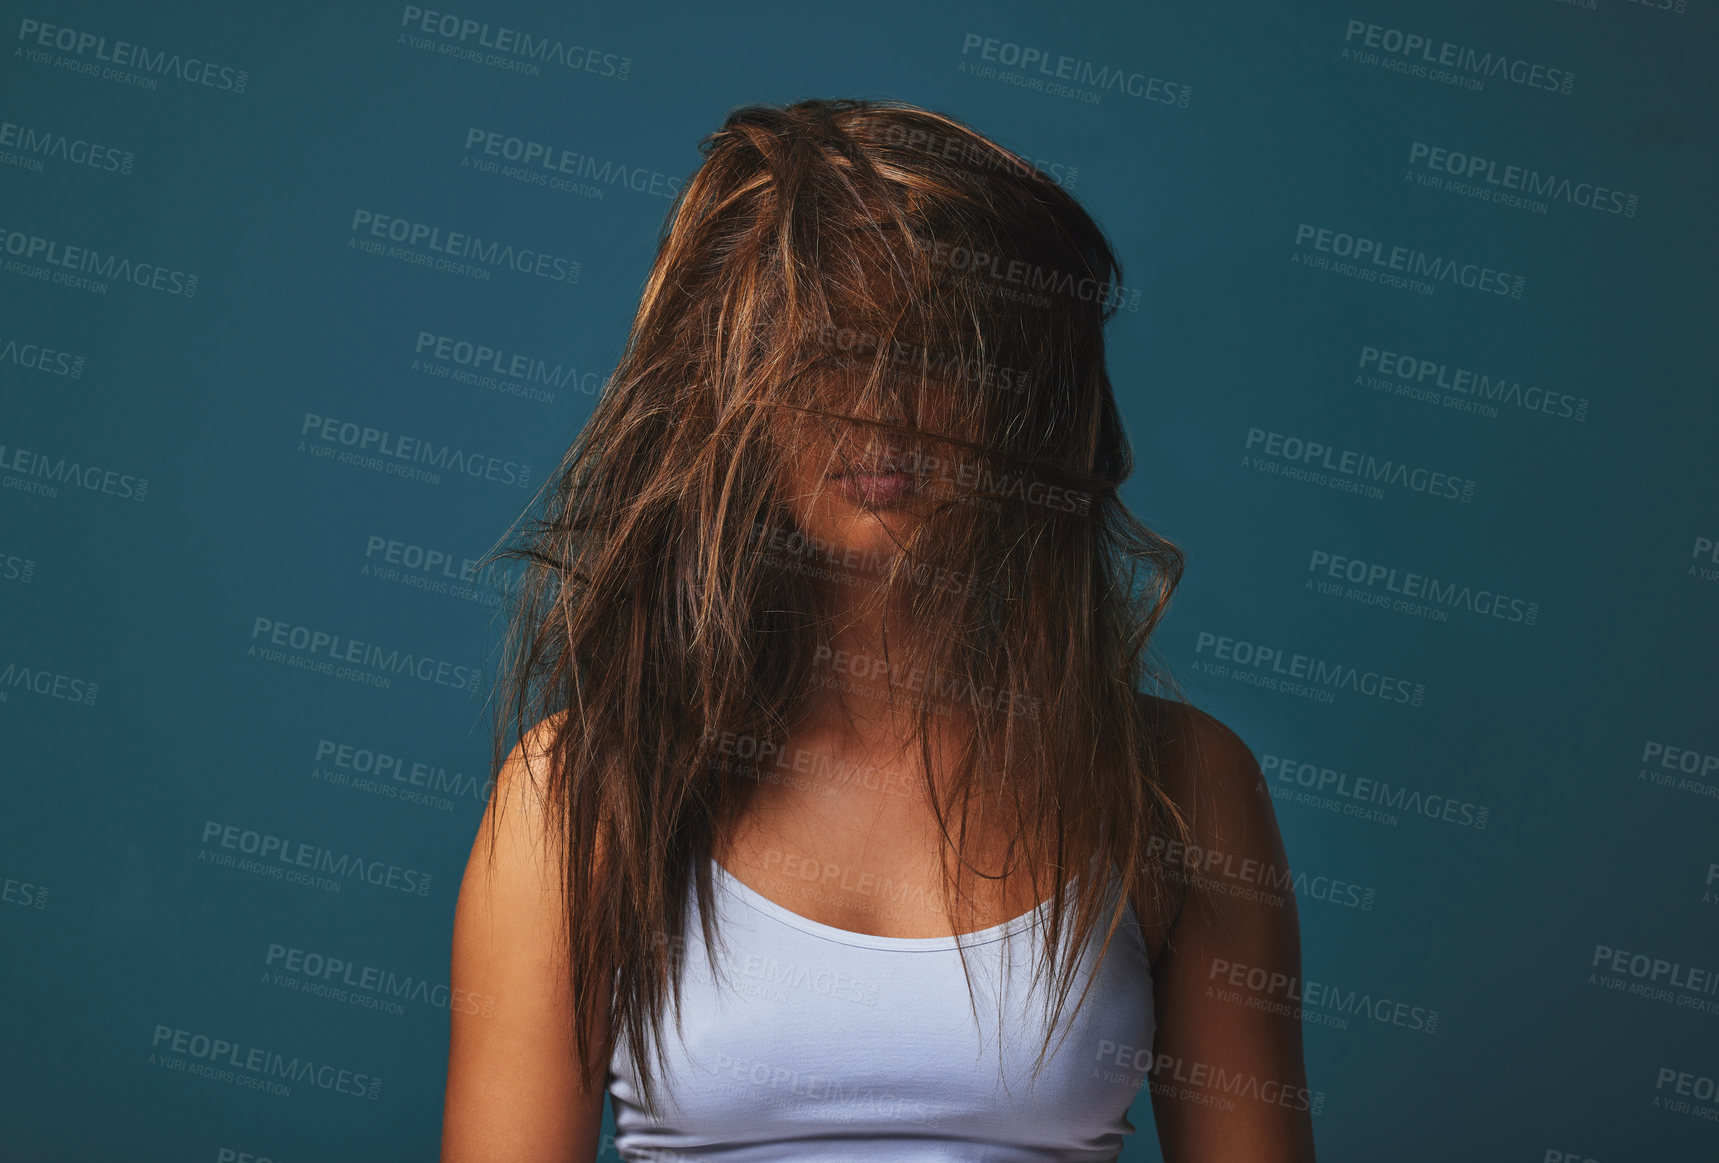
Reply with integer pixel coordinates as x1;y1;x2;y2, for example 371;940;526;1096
1152;708;1313;1163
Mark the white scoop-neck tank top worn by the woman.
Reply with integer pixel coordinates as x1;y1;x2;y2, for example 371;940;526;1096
609;848;1155;1163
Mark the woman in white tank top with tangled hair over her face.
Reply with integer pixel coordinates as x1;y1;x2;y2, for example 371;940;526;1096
442;100;1317;1163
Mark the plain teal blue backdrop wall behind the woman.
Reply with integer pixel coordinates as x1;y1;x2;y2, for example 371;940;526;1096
0;0;1719;1163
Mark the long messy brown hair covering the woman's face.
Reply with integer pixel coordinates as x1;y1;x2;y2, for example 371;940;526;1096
493;100;1210;1103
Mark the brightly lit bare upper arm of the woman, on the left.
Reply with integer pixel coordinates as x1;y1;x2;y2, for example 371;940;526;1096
442;720;607;1163
